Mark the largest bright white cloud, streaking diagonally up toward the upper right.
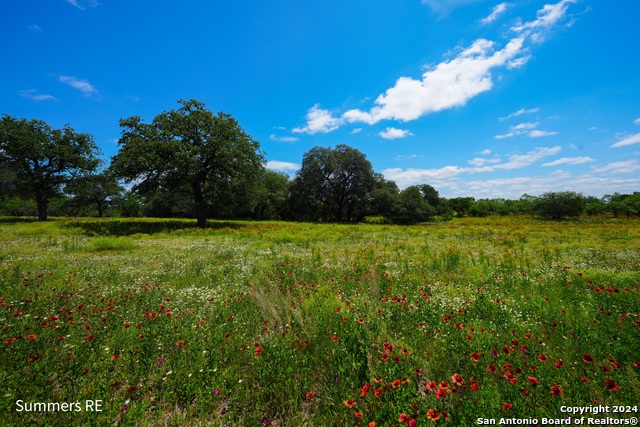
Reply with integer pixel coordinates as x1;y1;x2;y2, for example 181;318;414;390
294;0;577;137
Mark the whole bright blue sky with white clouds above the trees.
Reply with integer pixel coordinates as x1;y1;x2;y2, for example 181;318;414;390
0;0;640;198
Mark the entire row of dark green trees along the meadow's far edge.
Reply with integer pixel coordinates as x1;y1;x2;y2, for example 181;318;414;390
0;100;640;227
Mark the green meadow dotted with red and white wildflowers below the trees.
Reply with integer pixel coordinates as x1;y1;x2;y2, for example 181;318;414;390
0;216;640;426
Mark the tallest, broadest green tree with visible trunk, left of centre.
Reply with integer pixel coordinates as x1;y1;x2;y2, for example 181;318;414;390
111;99;264;227
